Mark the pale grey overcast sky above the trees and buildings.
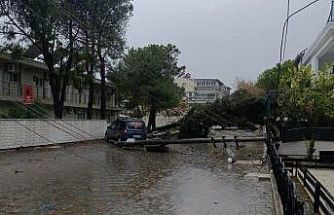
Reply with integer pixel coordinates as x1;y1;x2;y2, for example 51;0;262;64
127;0;331;87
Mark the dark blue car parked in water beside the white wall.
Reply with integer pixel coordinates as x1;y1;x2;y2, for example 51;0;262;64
105;118;147;142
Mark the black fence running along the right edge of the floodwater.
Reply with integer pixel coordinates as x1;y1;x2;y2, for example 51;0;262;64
267;142;304;215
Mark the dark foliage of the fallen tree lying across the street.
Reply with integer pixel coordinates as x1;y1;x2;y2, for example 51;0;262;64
179;89;265;138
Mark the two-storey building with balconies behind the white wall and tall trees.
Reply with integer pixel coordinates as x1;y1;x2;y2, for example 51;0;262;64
0;54;117;119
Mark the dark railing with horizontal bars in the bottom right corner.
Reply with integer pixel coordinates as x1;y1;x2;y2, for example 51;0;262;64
294;163;334;215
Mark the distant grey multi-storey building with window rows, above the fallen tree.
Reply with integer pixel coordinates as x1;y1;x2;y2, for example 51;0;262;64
193;79;231;103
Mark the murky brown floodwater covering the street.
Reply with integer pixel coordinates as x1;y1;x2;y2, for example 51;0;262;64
0;143;273;215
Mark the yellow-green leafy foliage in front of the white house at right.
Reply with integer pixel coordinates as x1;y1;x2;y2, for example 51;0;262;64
257;58;334;125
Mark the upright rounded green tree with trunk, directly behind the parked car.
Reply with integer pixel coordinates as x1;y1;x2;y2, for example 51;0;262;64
110;45;182;129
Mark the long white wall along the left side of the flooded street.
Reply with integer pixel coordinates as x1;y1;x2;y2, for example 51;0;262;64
0;120;107;150
